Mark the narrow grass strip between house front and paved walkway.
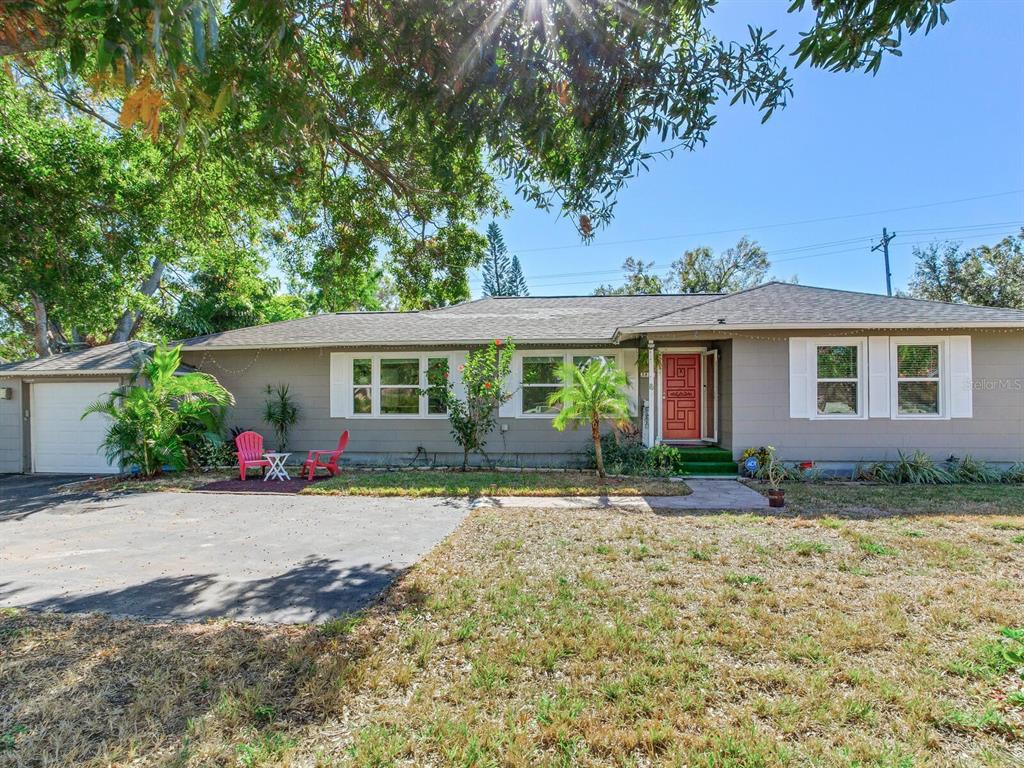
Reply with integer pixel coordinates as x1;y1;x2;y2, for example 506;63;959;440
302;470;690;497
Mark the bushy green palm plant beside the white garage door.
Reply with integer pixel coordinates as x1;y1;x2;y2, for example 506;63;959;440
82;344;234;477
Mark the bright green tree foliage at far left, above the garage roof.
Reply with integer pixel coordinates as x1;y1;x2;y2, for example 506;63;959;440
0;77;161;355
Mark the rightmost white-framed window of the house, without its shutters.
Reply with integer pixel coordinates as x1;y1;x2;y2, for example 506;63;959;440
892;337;948;419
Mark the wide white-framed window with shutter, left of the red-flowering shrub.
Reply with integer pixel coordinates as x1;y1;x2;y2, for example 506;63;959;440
331;352;459;419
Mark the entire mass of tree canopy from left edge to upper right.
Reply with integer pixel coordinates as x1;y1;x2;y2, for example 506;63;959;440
0;0;946;353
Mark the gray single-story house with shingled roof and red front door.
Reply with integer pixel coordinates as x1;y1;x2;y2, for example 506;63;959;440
0;283;1024;472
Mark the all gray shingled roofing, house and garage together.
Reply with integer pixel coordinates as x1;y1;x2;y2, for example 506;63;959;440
0;283;1024;377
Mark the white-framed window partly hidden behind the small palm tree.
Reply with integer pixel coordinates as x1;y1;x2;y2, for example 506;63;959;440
512;349;636;419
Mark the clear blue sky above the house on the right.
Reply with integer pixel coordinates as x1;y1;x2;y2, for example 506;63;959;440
470;0;1024;297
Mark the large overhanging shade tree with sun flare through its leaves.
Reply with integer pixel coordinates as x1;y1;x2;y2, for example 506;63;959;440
0;0;958;354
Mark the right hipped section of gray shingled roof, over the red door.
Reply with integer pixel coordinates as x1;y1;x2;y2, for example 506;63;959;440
620;283;1024;335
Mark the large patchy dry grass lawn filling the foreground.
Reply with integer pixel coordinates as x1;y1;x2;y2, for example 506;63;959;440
0;509;1024;768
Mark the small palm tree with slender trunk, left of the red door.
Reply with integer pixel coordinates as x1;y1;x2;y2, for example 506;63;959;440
548;357;630;477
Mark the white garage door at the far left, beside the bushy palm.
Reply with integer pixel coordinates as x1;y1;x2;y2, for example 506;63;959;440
31;381;118;474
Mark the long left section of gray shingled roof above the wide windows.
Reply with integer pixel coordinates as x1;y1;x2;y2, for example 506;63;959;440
178;294;714;349
